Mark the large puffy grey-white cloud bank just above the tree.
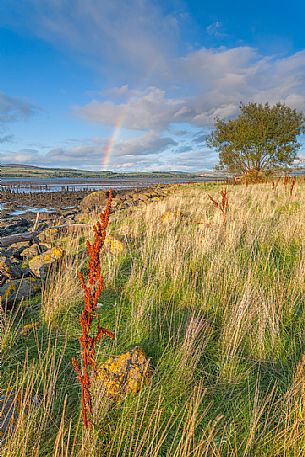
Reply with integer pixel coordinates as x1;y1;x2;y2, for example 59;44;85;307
75;47;305;130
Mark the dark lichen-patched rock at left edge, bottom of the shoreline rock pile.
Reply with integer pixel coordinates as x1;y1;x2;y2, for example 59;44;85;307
0;278;41;305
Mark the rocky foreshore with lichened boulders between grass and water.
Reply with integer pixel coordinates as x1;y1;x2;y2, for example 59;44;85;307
0;179;202;307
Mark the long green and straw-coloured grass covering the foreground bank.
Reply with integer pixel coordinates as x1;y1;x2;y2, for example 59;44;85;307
0;181;305;457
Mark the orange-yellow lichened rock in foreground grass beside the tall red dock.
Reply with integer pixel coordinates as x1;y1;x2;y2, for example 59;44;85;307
97;346;152;400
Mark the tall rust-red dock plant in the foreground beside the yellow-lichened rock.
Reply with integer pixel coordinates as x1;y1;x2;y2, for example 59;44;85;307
72;189;114;428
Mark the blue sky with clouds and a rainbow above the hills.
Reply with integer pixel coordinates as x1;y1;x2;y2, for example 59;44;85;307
0;0;305;172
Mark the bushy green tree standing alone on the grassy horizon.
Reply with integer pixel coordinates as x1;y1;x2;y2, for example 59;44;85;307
207;102;305;177
